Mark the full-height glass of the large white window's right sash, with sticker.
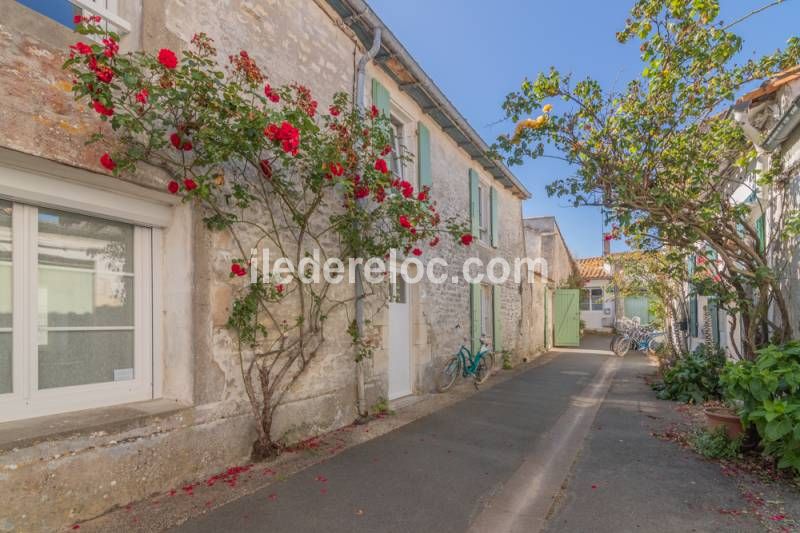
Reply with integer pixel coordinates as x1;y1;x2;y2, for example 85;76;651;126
37;209;134;389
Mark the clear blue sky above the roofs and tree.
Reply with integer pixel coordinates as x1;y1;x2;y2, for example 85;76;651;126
368;0;800;257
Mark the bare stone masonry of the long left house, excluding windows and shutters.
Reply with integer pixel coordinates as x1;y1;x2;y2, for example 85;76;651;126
0;0;539;531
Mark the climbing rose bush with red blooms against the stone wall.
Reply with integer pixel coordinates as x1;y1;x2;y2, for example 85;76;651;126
70;21;466;459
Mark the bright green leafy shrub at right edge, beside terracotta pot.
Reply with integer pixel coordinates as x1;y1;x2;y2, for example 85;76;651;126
722;341;800;473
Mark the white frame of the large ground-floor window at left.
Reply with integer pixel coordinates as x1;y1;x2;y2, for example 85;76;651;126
0;165;171;422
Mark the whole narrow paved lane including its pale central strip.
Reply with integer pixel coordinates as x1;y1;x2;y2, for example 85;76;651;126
169;337;763;532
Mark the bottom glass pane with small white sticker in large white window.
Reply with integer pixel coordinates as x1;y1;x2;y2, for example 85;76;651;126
39;330;134;390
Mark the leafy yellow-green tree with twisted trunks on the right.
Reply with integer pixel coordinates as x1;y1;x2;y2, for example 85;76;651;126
495;0;800;355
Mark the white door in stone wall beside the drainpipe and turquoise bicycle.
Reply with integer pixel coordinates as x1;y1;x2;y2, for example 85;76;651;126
388;276;411;400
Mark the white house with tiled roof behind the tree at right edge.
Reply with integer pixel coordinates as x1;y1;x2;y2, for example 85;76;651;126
687;65;800;358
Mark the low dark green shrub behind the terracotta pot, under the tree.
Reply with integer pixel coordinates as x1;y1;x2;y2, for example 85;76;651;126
653;344;725;403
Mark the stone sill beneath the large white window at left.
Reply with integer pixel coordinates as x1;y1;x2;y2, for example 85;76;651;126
0;399;189;453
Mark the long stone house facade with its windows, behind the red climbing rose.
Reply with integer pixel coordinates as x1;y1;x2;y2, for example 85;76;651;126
0;0;542;531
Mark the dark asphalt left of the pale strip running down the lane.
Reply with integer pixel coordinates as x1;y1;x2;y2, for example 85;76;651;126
170;353;608;533
